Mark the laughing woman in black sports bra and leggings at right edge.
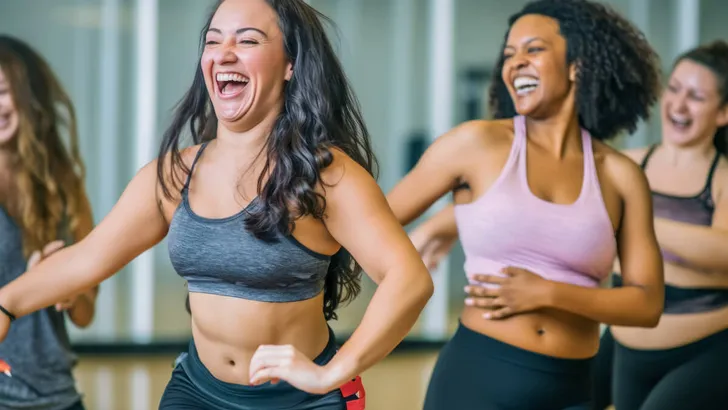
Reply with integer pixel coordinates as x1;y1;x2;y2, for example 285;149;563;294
594;41;728;410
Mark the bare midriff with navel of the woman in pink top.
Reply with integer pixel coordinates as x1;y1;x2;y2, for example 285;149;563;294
461;306;599;359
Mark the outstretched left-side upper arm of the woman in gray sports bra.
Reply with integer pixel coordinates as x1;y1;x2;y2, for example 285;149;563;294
75;161;168;278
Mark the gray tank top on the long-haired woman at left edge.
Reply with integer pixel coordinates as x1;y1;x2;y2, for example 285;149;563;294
0;206;81;410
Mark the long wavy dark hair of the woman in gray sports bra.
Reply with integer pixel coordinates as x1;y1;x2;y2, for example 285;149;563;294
157;0;377;320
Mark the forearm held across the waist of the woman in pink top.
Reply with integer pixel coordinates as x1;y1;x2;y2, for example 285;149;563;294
547;282;664;327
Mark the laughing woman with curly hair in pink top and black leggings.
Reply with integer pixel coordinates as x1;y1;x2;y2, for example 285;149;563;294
388;0;663;410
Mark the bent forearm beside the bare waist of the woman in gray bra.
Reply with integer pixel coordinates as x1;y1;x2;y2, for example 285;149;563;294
326;274;433;388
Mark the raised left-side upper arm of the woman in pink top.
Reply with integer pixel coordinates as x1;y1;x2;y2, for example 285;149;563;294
387;121;484;225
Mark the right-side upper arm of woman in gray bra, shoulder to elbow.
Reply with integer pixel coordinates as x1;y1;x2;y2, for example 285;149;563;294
322;151;432;286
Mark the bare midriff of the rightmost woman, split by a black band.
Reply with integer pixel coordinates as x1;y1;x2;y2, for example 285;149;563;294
611;263;728;349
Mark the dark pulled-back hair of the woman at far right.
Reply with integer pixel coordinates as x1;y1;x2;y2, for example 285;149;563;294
673;40;728;156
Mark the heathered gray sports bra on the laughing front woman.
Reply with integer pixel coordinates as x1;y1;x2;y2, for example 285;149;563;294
167;143;331;302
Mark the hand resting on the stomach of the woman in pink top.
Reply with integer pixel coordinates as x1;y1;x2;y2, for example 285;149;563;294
465;266;552;319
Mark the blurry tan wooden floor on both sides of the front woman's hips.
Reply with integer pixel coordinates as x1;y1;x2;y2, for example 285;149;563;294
76;352;437;410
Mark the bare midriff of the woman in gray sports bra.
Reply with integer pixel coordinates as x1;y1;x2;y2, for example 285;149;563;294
190;293;329;385
